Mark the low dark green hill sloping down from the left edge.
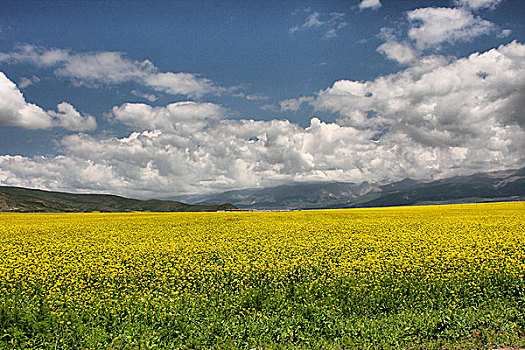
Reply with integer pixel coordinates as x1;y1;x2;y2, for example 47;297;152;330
0;186;236;212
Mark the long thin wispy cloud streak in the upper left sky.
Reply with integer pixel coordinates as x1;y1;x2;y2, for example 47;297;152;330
0;45;215;97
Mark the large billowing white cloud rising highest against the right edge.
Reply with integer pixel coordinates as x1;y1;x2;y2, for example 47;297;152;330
312;42;525;144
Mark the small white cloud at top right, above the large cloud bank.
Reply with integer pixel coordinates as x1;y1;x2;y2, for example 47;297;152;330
407;7;496;49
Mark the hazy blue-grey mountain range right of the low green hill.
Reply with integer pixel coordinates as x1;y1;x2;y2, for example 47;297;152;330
177;168;525;209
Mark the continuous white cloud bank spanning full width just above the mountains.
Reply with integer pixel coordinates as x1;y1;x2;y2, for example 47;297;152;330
0;42;525;198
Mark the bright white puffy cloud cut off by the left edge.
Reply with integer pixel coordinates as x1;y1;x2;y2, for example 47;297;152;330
0;72;97;131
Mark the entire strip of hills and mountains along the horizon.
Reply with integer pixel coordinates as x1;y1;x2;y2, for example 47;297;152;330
0;168;525;212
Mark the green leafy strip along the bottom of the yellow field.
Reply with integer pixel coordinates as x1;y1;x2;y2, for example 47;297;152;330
0;279;525;349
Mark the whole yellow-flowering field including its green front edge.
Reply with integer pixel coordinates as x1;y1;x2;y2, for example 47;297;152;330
0;202;525;349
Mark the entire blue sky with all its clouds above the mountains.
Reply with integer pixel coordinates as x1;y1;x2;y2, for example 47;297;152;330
0;0;525;198
